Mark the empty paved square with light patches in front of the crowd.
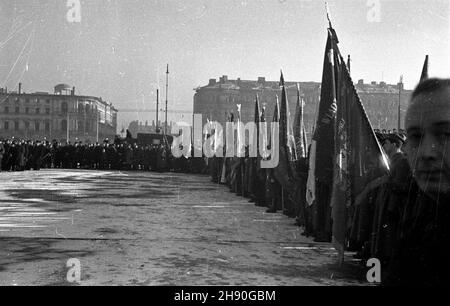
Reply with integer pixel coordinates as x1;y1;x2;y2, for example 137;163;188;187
0;170;366;286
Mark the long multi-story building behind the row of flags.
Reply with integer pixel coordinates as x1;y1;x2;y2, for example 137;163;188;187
194;75;411;137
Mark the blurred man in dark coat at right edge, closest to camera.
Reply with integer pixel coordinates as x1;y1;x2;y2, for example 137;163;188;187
383;79;450;288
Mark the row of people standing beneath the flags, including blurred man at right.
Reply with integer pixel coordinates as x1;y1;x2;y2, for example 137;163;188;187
210;79;450;286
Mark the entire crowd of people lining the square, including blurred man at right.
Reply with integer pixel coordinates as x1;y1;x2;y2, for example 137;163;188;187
0;79;450;286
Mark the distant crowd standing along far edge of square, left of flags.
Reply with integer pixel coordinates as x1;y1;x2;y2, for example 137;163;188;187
0;138;206;173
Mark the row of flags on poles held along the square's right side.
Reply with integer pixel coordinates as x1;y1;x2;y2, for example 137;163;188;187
188;22;429;263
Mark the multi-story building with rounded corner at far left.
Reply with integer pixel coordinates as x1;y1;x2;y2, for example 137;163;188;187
0;84;117;142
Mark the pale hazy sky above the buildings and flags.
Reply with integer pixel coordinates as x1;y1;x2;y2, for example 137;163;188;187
0;0;450;128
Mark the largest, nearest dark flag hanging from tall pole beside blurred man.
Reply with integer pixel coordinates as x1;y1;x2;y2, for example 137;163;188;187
316;28;389;262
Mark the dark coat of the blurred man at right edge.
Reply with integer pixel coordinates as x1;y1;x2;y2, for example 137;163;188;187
383;188;450;288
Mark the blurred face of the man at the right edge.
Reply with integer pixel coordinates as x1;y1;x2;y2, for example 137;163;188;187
405;87;450;197
